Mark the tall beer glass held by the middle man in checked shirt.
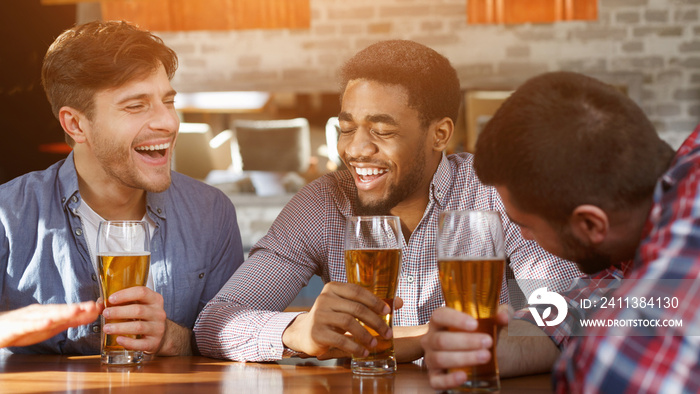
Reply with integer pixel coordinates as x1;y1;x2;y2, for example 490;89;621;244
345;216;402;375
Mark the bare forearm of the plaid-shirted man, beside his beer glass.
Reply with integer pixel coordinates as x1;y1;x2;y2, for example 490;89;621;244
497;320;560;378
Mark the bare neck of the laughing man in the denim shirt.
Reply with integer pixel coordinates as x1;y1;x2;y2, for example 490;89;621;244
73;152;146;220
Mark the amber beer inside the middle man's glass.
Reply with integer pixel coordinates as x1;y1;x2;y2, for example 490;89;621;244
345;249;401;361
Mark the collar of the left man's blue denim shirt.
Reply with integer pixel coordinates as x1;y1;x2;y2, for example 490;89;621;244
58;151;167;223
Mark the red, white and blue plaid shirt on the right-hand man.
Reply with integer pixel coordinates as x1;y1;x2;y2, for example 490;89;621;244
553;128;700;394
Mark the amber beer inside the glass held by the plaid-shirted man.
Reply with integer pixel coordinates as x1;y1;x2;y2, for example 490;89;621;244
438;258;505;388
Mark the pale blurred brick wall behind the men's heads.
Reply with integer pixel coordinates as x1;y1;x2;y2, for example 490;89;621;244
83;0;700;147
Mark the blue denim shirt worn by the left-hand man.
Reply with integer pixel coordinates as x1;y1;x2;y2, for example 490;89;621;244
0;153;243;354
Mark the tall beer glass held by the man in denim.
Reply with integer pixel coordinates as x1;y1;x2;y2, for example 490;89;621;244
96;220;151;365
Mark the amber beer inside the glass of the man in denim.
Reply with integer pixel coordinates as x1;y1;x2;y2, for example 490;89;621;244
98;253;151;353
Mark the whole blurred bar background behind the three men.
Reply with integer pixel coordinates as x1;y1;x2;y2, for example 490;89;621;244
0;0;700;305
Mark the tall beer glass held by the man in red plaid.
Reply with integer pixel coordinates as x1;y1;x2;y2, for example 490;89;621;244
437;211;505;392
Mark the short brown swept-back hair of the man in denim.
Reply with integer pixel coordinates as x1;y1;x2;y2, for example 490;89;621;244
41;21;177;144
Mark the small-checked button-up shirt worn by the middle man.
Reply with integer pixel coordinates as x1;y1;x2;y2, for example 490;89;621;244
194;153;581;361
